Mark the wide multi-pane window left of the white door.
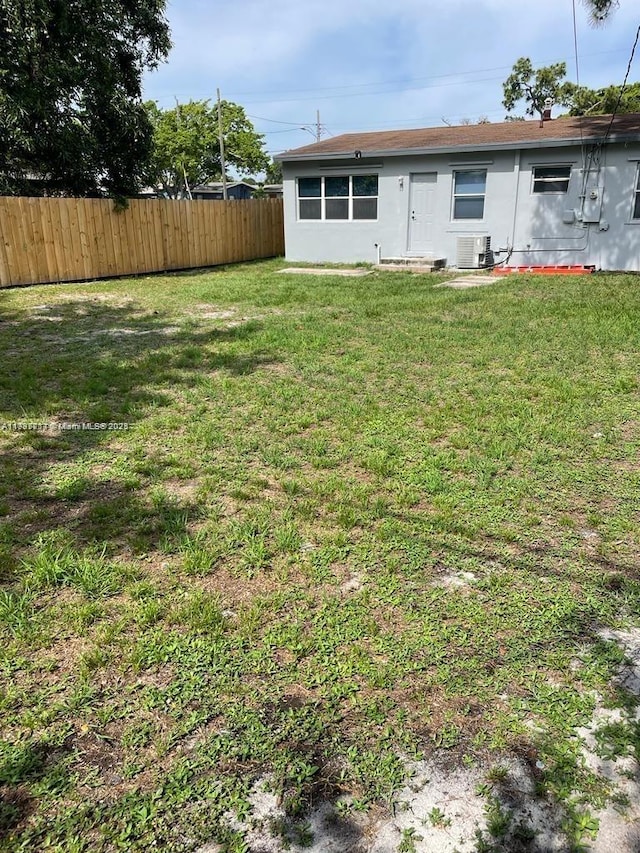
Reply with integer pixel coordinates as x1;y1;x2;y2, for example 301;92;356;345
298;175;378;220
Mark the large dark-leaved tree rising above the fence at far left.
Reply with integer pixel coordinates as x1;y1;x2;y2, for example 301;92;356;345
0;0;171;197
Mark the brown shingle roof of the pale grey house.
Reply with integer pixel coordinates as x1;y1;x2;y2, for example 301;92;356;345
275;113;640;161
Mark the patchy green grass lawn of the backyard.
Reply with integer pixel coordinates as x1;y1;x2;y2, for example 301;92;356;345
0;261;640;853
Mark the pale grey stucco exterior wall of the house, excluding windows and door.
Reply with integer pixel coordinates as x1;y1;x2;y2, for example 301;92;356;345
283;143;640;270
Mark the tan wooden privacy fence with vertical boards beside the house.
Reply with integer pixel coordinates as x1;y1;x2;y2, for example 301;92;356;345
0;197;284;287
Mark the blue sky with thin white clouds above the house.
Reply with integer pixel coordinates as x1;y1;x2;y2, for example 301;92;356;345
144;0;640;160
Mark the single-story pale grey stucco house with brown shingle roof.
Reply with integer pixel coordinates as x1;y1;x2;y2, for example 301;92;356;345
277;114;640;270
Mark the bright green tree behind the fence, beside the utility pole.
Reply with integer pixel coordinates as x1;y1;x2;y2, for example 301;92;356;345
145;101;269;198
